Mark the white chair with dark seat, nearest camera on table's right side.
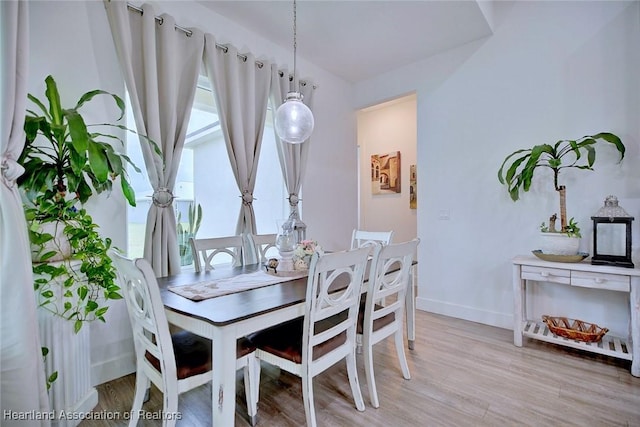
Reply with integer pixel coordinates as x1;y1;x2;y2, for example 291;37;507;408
249;248;369;427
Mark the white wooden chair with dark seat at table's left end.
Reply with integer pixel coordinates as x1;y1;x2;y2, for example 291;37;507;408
109;249;260;427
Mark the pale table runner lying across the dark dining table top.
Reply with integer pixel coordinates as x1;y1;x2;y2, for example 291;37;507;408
167;270;308;301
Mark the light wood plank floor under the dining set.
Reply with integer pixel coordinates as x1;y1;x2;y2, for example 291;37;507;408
80;311;640;427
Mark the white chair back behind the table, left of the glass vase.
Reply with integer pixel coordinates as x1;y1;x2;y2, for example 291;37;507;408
189;235;244;271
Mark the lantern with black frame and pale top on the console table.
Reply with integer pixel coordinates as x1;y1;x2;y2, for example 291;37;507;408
591;196;633;268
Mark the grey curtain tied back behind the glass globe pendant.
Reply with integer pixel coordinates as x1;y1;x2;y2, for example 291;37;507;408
270;64;314;226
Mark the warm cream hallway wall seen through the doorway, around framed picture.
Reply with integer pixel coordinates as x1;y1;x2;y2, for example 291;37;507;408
358;95;420;242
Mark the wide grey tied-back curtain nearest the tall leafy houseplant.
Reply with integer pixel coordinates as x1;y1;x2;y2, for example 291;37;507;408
105;0;204;276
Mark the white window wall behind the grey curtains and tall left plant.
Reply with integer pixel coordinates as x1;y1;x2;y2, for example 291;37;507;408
28;1;357;384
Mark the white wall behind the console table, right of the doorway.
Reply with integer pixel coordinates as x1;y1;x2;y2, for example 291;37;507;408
354;2;640;334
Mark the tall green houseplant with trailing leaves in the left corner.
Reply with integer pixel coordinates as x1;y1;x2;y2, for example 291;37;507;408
18;76;151;332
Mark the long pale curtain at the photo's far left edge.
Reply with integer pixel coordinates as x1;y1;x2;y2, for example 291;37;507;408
0;1;51;426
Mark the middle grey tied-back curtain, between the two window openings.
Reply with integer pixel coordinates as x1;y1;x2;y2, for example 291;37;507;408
204;34;271;234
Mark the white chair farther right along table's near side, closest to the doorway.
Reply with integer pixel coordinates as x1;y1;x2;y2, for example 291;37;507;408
357;238;420;408
